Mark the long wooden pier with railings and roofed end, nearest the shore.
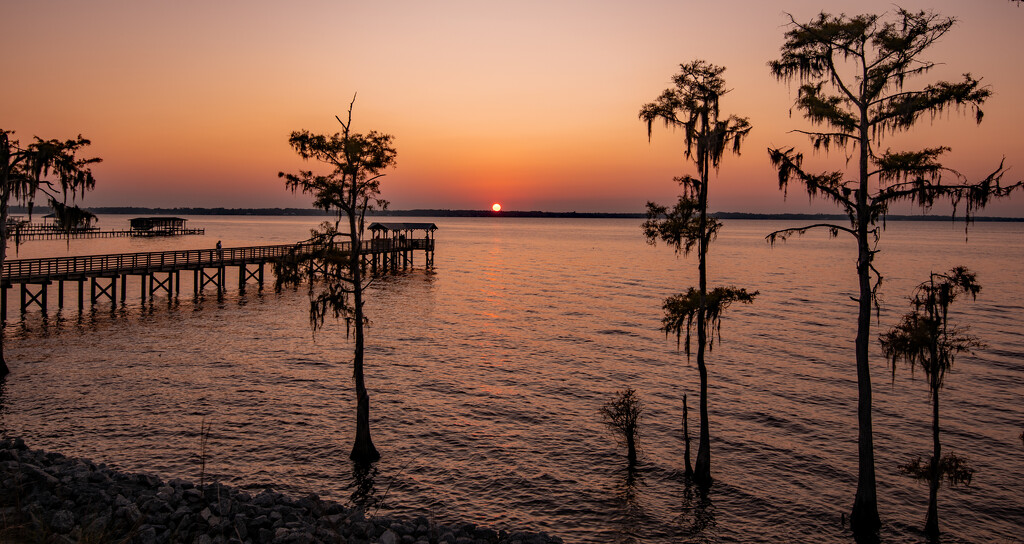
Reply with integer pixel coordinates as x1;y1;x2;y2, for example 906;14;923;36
0;232;434;321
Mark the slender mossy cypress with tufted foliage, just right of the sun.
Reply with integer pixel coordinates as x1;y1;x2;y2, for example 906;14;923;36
640;60;758;487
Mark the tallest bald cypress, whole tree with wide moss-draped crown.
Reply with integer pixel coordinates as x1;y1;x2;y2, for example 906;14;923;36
767;9;1021;538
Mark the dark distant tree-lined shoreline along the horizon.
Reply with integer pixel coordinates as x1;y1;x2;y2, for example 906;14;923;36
11;206;1024;222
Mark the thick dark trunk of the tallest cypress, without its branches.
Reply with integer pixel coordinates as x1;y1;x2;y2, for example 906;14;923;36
850;99;882;540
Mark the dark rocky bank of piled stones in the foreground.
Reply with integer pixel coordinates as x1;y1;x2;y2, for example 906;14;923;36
0;438;562;544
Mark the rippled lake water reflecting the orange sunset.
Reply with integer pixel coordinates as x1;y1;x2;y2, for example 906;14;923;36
0;216;1024;543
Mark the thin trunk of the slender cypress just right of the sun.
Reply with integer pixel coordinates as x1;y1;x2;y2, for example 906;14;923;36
693;132;712;488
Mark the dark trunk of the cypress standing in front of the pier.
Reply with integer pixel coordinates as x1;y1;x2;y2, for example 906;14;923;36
348;213;381;464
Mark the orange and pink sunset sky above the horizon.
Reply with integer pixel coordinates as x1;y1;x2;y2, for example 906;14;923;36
0;0;1024;216
